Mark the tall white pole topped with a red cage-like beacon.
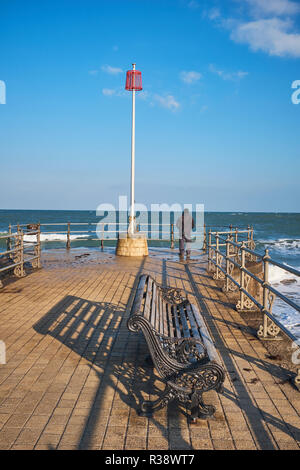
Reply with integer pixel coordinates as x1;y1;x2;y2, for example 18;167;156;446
125;64;142;235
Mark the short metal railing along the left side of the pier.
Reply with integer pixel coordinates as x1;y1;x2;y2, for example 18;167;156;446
0;224;41;287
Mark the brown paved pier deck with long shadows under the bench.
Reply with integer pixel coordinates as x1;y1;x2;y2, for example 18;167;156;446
0;250;300;450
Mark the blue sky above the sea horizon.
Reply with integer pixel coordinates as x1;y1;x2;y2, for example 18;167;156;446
0;0;300;212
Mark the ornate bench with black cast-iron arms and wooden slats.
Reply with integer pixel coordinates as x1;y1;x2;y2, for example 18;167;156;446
127;274;225;422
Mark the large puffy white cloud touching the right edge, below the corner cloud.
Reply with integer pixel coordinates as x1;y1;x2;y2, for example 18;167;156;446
231;18;300;57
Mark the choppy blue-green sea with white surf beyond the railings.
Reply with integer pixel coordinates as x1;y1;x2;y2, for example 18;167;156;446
0;210;300;341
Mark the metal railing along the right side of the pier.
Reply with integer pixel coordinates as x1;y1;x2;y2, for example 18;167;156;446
208;230;300;390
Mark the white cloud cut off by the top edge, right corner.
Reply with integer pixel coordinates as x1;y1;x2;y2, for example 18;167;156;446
244;0;300;16
